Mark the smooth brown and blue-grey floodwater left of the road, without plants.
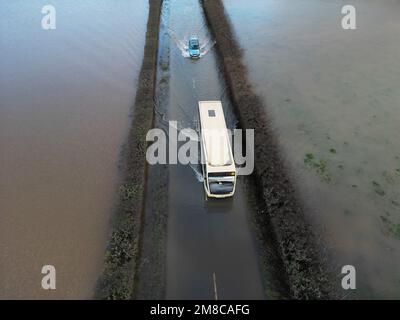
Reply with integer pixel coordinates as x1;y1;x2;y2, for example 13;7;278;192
0;0;148;299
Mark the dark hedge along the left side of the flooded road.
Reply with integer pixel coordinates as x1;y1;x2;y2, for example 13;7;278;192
95;0;163;300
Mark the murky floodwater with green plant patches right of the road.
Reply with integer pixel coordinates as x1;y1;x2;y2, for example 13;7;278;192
224;0;400;298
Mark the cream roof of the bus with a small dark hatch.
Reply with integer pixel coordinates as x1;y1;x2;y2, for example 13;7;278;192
199;101;234;171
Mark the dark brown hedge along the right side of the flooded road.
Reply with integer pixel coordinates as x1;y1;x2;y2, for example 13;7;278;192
201;0;335;299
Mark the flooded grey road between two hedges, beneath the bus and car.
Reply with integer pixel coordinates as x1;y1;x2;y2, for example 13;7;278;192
157;0;265;299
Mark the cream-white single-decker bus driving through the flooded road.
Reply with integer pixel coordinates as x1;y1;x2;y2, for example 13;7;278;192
199;101;236;198
